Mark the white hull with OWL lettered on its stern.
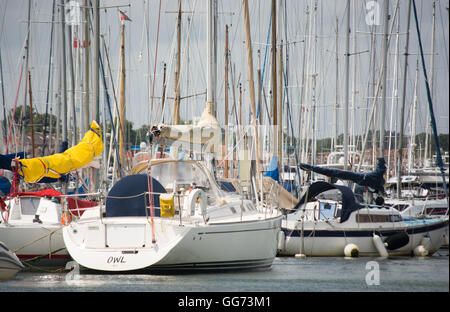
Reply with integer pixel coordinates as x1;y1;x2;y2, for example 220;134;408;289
63;216;281;271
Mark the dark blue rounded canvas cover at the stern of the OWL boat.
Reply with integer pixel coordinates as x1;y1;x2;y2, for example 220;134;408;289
106;174;167;217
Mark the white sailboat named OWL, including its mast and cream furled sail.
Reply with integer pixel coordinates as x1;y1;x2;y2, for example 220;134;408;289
63;1;282;272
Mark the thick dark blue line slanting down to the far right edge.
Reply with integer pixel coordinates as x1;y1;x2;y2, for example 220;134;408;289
412;0;449;203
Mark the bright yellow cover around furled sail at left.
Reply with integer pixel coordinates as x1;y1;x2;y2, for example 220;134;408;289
17;121;103;182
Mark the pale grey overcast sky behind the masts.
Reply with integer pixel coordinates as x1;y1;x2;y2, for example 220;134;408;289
0;0;449;146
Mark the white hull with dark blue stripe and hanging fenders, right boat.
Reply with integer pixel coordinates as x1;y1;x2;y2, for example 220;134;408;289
278;219;448;257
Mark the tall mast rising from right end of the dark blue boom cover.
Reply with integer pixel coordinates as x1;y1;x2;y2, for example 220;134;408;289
379;0;389;157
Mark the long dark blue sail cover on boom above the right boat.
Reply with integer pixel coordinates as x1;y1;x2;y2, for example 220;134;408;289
300;158;386;193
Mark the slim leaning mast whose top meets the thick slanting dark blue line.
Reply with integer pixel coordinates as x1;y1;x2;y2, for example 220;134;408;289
397;0;412;198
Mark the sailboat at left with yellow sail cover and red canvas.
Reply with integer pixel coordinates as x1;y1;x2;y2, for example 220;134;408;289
0;121;103;266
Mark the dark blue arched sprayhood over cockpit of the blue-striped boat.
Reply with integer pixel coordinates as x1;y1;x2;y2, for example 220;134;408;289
293;181;363;223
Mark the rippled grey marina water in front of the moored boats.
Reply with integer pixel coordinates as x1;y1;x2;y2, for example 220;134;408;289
0;249;449;295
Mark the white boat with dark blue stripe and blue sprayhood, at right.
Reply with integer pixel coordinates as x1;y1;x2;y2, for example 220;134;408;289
278;182;448;257
